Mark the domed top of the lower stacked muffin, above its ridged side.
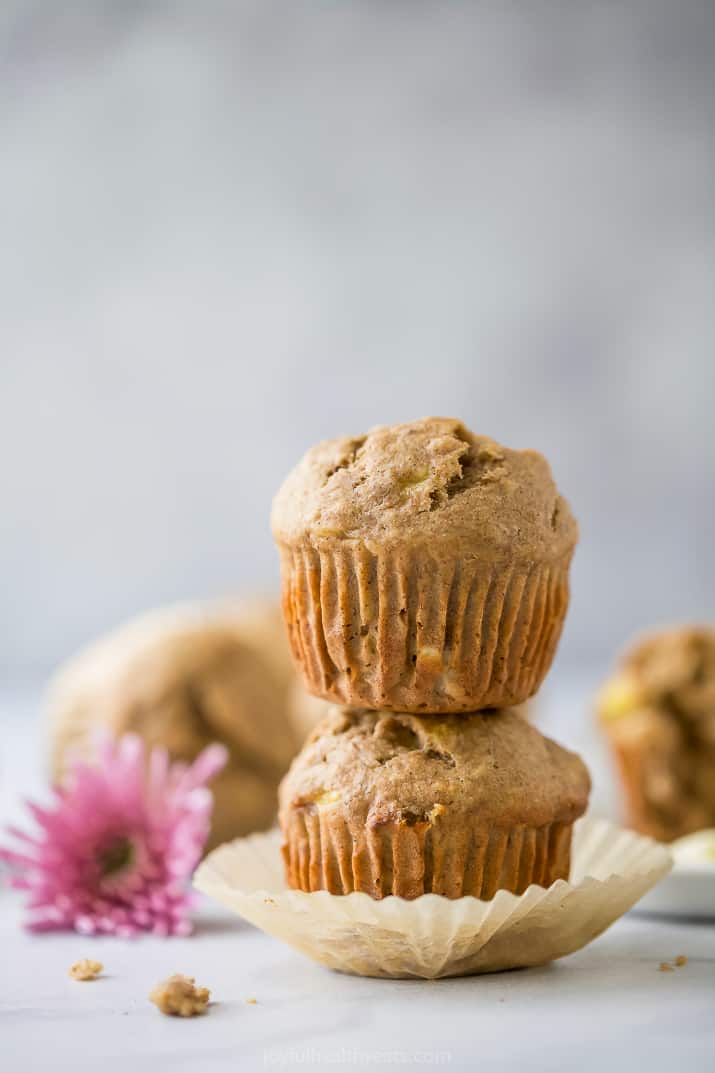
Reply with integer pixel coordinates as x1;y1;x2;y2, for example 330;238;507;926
279;706;590;826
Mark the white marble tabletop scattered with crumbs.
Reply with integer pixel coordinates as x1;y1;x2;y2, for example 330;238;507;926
0;677;715;1073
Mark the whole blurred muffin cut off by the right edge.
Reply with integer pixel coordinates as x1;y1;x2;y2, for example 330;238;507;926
598;626;715;841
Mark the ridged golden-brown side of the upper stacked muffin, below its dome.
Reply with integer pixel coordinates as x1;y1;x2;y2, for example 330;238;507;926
274;541;571;712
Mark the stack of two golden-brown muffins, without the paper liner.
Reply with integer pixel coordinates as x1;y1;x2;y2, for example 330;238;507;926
273;417;589;898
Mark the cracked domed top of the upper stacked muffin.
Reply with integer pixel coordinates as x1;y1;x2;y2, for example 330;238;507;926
272;417;578;559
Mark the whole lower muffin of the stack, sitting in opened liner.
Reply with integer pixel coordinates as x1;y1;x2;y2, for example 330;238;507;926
279;707;590;899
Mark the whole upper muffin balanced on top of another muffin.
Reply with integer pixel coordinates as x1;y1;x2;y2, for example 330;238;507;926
272;417;578;712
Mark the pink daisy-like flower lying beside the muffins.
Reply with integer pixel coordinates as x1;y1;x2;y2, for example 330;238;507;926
0;734;227;937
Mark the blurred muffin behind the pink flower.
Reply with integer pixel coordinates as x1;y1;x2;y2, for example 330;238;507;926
48;601;318;848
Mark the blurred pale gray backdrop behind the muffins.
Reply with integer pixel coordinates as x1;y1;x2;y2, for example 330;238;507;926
0;0;715;680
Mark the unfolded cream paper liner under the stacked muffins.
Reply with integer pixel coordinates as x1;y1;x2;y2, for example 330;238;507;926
194;818;672;980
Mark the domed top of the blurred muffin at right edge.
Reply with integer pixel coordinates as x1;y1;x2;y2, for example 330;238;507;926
598;626;715;745
